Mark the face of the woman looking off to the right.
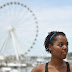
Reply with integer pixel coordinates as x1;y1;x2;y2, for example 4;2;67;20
51;35;68;59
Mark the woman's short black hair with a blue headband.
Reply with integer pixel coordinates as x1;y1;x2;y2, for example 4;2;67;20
44;31;66;53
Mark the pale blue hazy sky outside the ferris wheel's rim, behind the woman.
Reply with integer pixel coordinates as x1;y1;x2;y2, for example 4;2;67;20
0;0;72;56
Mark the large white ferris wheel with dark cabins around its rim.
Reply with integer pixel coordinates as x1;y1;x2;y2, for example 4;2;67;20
0;2;38;57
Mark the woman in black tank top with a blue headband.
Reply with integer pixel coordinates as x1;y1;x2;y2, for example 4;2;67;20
31;31;72;72
